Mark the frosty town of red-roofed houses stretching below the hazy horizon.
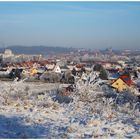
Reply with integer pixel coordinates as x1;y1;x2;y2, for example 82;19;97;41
0;47;140;95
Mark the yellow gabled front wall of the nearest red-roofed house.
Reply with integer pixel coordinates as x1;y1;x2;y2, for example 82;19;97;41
111;78;129;92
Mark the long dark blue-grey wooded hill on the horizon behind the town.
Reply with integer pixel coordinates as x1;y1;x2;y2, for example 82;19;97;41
0;46;75;56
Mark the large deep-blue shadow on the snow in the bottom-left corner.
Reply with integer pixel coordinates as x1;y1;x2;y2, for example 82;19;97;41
0;115;49;138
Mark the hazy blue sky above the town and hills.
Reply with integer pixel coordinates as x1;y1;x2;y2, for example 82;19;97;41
0;2;140;48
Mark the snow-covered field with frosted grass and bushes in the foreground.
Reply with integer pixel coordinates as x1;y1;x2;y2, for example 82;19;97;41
0;81;140;139
